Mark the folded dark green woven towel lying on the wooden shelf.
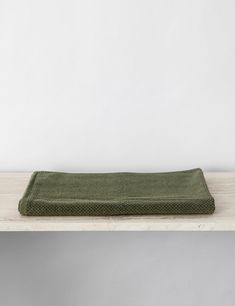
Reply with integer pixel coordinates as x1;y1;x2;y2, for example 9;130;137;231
19;169;215;216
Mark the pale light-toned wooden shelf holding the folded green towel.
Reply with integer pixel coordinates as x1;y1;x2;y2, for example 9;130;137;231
0;172;235;231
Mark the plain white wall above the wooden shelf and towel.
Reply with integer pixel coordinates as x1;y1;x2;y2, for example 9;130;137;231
0;0;235;171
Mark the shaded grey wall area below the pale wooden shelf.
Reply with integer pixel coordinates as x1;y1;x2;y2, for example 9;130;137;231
0;232;235;306
